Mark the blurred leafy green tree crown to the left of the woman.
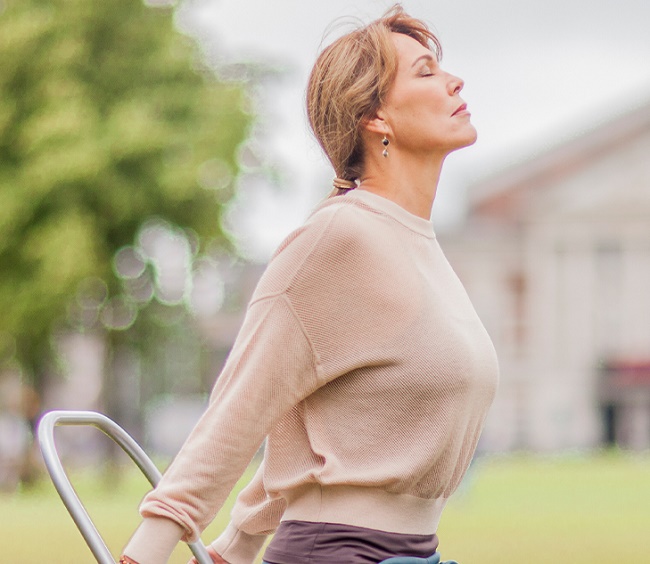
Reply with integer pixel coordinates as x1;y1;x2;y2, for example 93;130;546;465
0;0;251;386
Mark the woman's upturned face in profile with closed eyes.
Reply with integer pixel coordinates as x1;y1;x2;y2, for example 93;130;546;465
378;33;476;156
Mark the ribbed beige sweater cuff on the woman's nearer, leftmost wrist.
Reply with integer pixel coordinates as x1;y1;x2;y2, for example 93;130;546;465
124;517;185;564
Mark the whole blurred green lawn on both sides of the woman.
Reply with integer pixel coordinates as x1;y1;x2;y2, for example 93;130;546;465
0;453;650;564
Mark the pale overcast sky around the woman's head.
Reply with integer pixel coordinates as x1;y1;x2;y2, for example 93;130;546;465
177;0;650;259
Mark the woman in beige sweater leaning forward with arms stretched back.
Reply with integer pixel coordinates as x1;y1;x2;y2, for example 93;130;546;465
124;6;497;564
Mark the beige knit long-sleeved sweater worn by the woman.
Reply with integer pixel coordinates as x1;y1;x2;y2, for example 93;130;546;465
126;189;498;564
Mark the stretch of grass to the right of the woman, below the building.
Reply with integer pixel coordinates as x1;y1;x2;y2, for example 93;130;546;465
438;453;650;564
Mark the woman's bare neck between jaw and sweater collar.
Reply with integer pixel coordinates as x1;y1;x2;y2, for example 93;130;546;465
359;149;445;220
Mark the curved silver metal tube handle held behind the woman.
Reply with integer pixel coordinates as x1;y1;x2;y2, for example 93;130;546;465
38;411;212;564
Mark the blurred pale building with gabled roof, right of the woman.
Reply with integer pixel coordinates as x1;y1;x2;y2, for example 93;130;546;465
440;104;650;450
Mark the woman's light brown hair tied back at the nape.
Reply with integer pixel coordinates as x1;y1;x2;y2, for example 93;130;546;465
307;4;442;187
